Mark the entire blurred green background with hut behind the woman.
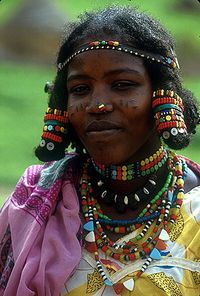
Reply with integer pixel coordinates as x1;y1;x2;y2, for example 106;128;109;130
0;0;200;203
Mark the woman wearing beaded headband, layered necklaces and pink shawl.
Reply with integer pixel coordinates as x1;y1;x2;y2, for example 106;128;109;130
0;7;200;296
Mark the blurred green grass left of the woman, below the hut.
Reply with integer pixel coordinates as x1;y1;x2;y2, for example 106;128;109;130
0;63;53;186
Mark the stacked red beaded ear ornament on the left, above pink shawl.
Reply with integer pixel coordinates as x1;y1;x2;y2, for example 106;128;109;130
35;108;69;161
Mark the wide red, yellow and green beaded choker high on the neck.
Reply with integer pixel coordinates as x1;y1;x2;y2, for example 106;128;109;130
92;145;167;181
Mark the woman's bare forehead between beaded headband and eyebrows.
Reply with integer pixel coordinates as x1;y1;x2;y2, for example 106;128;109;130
68;49;147;74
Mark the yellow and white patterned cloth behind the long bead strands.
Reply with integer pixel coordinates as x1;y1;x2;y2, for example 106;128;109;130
61;180;200;296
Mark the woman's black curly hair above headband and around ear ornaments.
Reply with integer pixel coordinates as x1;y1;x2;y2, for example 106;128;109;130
35;6;199;161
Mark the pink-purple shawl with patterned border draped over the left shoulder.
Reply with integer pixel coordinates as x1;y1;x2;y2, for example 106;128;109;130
0;157;81;296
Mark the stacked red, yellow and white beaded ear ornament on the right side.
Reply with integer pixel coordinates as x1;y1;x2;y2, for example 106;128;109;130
152;89;189;149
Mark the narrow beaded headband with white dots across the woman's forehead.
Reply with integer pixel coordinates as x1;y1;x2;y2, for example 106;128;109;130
58;41;179;71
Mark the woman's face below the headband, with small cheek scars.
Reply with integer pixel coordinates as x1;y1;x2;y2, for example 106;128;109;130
67;50;152;165
